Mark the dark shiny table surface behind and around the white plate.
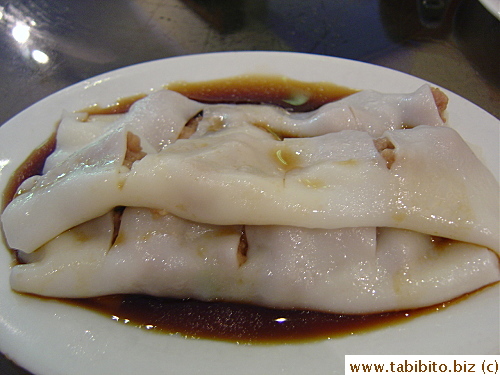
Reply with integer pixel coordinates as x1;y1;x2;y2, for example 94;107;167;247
0;0;500;375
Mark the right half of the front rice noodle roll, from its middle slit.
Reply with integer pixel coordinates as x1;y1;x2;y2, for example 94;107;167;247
241;226;500;314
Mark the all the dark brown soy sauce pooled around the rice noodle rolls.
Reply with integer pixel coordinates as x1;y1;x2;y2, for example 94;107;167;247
4;76;460;344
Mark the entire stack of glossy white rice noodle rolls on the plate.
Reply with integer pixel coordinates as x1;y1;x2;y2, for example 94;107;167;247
2;86;500;313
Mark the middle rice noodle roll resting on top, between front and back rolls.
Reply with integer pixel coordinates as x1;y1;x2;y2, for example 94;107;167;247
2;125;499;252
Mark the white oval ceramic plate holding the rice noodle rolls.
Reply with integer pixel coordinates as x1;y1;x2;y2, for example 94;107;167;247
0;52;499;375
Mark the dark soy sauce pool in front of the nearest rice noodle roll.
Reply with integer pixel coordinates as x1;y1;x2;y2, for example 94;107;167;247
69;295;460;344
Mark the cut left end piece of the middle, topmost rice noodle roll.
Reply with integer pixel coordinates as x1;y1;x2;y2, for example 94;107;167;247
2;128;128;252
